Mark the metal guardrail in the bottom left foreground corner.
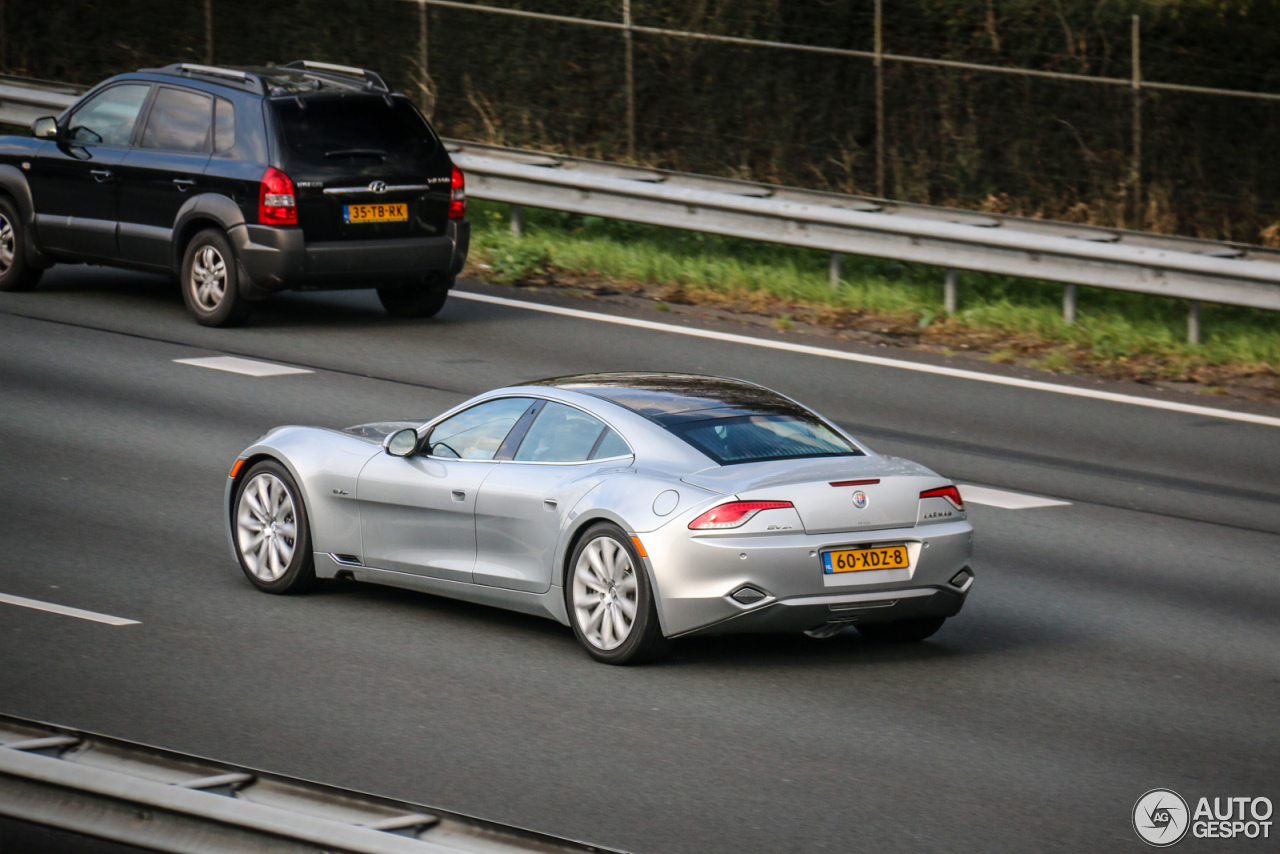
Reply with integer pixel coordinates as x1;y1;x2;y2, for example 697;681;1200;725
0;716;617;854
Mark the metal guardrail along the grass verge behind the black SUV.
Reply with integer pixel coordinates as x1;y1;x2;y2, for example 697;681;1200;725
0;78;1280;342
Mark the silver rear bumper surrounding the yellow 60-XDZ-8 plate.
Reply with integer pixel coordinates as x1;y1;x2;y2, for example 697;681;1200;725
640;521;973;638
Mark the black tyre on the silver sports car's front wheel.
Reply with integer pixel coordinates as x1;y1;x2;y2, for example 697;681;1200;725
232;460;316;593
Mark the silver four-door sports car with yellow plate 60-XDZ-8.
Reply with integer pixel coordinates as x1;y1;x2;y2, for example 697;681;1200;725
225;373;973;665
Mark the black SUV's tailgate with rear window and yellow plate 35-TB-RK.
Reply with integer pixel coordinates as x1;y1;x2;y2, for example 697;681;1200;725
271;92;453;243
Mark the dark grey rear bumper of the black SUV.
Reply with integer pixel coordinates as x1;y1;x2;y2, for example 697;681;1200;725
228;219;471;298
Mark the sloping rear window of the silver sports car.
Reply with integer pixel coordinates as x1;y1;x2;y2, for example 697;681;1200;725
667;415;863;466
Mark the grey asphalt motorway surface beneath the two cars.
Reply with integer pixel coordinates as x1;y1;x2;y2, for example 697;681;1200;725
0;268;1280;854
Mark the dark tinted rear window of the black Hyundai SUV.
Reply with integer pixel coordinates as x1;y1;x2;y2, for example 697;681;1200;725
273;93;438;166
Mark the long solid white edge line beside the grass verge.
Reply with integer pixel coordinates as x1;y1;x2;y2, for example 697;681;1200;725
451;291;1280;426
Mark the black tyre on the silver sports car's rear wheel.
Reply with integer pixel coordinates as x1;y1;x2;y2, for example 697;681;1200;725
564;522;671;665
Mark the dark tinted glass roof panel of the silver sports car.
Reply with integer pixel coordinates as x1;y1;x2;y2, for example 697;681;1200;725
526;373;813;426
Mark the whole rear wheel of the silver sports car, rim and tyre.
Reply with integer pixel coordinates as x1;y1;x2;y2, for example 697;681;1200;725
564;522;668;665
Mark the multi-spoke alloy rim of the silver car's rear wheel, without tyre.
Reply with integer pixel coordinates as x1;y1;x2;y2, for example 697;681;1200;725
573;536;639;650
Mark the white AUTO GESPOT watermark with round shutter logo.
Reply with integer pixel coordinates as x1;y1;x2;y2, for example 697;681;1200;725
1133;789;1271;848
